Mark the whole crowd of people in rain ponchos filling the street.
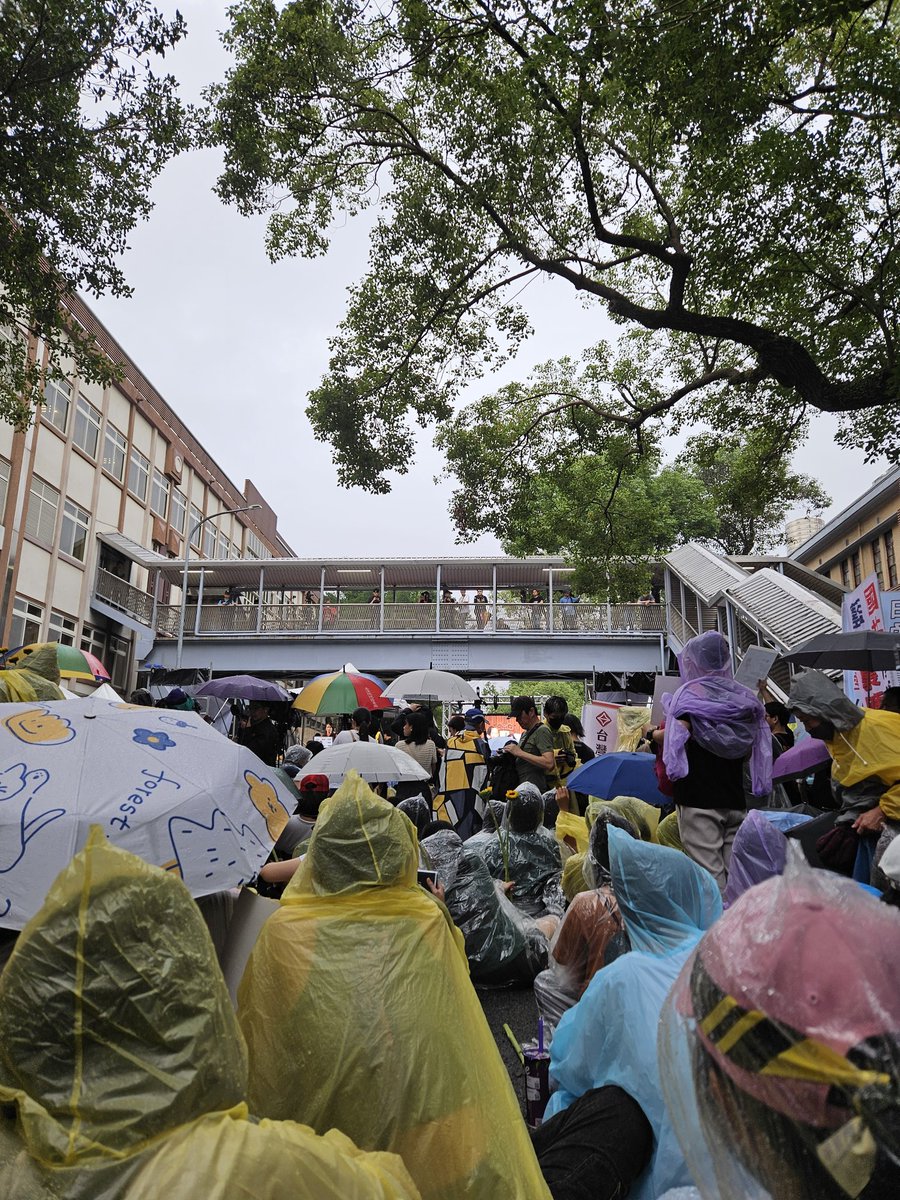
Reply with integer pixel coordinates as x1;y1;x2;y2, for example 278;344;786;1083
0;632;900;1200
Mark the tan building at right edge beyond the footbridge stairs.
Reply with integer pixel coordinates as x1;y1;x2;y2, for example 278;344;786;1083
791;467;900;590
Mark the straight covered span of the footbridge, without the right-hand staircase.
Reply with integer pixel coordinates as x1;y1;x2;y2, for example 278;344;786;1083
92;549;665;678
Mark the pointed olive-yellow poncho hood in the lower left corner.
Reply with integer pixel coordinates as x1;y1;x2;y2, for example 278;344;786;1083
0;828;247;1165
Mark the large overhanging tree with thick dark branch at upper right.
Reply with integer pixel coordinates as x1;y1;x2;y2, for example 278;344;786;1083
212;0;900;492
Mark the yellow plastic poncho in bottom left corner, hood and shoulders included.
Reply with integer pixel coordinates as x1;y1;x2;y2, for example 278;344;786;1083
0;829;418;1200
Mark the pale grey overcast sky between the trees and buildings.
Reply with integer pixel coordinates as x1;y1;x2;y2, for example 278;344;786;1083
89;0;886;557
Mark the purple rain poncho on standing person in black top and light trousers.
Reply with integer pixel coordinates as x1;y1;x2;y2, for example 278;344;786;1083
662;630;772;796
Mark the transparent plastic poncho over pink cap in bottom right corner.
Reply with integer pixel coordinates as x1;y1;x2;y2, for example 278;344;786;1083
659;860;900;1200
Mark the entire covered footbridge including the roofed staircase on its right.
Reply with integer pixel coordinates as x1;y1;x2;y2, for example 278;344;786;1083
91;534;845;695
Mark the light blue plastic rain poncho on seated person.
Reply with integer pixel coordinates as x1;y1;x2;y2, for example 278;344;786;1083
546;828;722;1200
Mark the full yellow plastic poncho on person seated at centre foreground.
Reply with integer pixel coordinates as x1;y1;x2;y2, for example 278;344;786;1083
238;774;550;1200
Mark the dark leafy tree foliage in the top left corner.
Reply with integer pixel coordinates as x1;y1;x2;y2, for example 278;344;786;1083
0;0;190;426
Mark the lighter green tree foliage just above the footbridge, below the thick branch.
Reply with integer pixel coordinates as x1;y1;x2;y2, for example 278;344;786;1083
438;336;829;576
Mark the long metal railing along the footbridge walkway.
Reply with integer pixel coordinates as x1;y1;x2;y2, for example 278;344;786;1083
154;600;666;637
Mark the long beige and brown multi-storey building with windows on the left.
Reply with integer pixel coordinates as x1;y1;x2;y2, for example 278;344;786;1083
0;286;293;689
